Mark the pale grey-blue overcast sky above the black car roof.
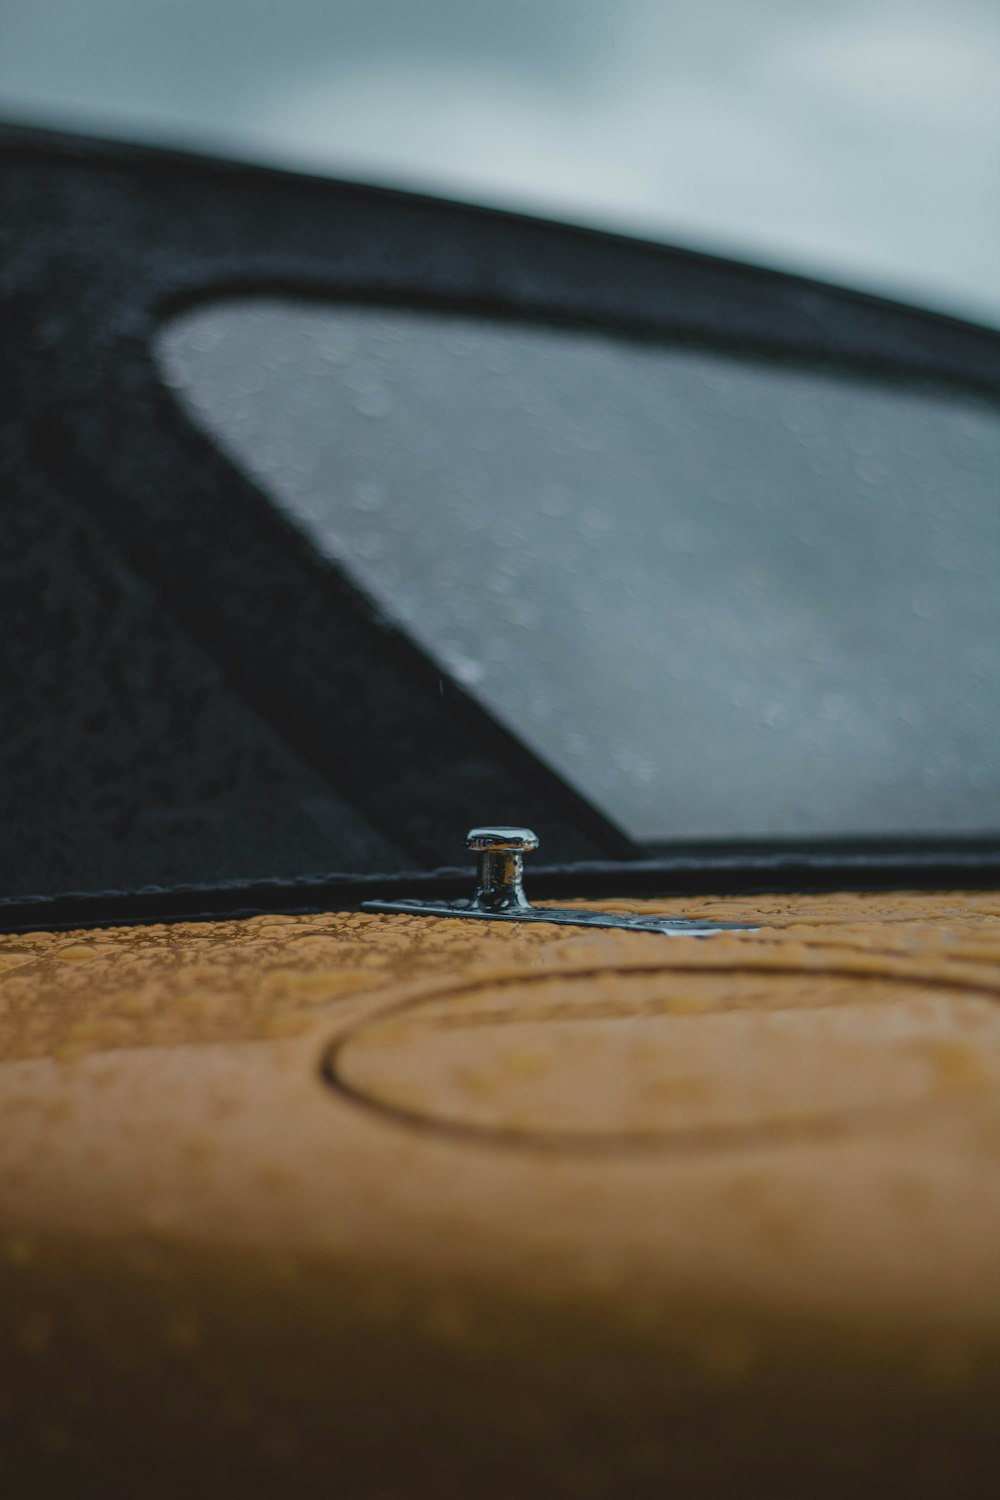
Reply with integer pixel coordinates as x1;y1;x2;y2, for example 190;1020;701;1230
0;0;1000;323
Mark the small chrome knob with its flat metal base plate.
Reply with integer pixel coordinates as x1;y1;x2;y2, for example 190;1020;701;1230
361;828;754;938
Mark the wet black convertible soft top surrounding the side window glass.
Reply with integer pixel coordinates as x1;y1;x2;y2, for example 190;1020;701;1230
0;120;1000;923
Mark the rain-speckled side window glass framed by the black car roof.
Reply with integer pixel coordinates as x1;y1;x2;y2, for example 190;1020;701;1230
159;299;1000;842
